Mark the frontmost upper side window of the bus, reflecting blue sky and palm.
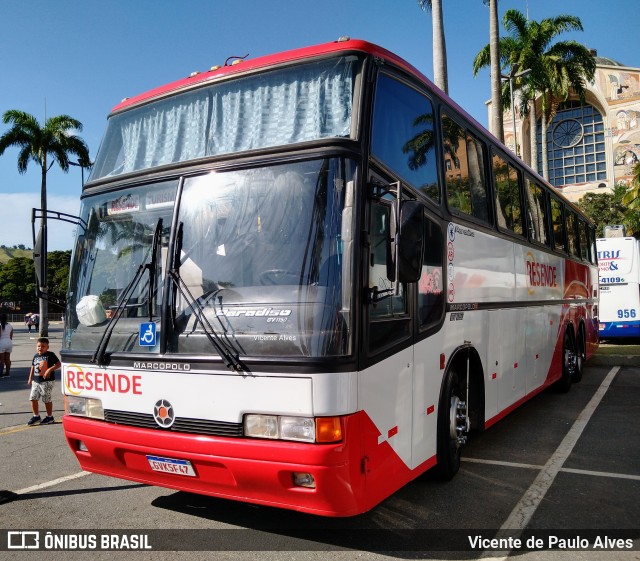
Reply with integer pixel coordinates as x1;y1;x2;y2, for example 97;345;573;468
371;74;440;201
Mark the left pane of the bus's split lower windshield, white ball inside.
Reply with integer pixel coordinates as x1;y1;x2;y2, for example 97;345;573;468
64;180;178;352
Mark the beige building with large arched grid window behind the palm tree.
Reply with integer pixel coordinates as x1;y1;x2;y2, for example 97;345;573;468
498;51;640;201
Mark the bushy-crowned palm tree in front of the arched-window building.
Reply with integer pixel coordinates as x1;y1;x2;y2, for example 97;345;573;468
473;10;595;174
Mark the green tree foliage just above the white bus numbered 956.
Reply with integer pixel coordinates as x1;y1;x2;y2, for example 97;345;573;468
578;183;640;237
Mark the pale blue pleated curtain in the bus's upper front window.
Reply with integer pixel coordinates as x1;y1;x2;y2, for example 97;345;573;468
92;57;356;179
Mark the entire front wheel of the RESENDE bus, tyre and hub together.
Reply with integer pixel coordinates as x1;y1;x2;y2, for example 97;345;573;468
436;370;469;481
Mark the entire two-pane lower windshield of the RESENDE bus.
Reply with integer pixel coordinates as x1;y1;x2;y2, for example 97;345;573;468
65;158;354;357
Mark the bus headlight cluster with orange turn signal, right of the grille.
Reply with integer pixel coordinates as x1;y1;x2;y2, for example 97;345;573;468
244;414;342;443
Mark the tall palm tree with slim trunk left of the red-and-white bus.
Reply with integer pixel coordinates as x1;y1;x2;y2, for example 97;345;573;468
0;109;90;337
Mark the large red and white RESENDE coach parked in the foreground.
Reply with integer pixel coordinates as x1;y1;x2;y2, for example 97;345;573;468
62;39;598;516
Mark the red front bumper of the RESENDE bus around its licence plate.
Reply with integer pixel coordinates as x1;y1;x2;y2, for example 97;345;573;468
63;414;372;516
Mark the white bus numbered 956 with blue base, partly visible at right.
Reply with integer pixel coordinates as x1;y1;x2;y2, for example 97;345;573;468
596;226;640;339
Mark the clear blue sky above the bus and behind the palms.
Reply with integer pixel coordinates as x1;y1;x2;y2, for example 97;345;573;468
0;0;640;251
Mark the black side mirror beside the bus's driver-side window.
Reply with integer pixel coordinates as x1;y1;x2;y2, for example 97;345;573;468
387;201;425;285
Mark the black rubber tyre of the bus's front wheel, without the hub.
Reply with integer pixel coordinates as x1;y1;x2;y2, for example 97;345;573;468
435;369;463;481
